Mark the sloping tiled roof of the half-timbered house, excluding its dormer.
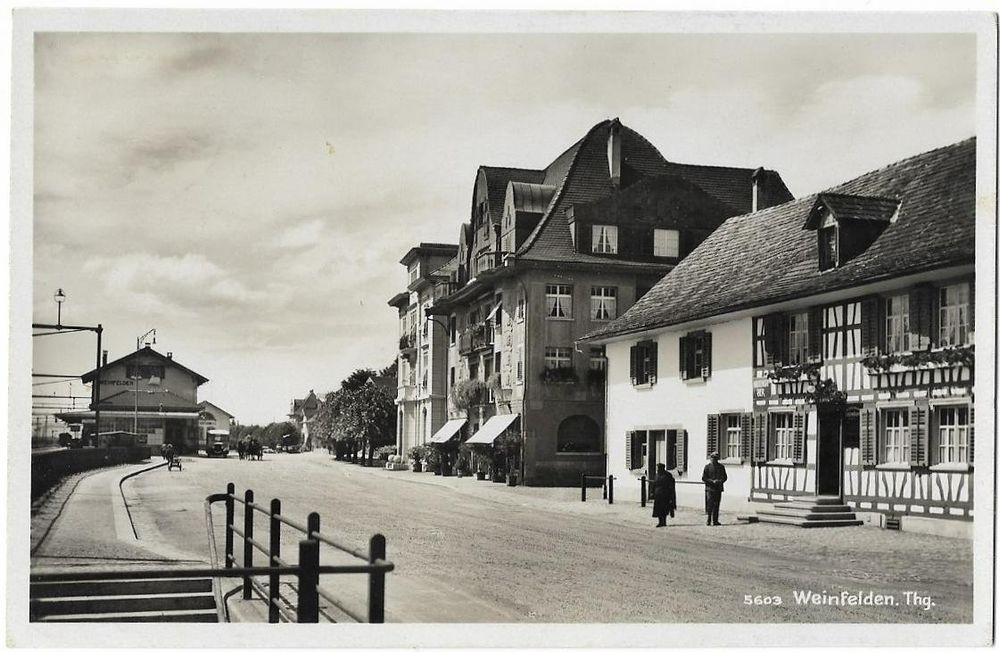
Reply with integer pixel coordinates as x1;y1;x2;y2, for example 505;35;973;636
586;138;976;339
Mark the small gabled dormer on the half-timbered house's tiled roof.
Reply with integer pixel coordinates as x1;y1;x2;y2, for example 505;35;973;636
802;193;899;272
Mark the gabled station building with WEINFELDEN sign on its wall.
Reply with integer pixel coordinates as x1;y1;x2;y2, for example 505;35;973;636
58;344;208;451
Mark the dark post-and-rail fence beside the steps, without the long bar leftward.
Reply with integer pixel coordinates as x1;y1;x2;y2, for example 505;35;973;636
219;483;394;623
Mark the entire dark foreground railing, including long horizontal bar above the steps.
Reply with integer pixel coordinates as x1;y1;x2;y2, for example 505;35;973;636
29;483;395;623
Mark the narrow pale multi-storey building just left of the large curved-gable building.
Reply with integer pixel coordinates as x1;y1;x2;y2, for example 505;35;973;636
389;242;458;459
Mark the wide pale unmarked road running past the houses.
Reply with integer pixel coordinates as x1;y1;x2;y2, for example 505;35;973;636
126;453;972;623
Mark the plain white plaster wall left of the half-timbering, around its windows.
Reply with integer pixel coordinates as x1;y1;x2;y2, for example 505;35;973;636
606;318;753;510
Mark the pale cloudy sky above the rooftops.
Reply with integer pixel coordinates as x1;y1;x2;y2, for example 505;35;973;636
32;33;976;423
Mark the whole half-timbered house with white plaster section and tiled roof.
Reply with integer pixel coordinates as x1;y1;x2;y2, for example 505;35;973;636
584;140;976;520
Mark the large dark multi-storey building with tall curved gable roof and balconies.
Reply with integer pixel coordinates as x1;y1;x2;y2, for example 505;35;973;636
397;119;791;485
